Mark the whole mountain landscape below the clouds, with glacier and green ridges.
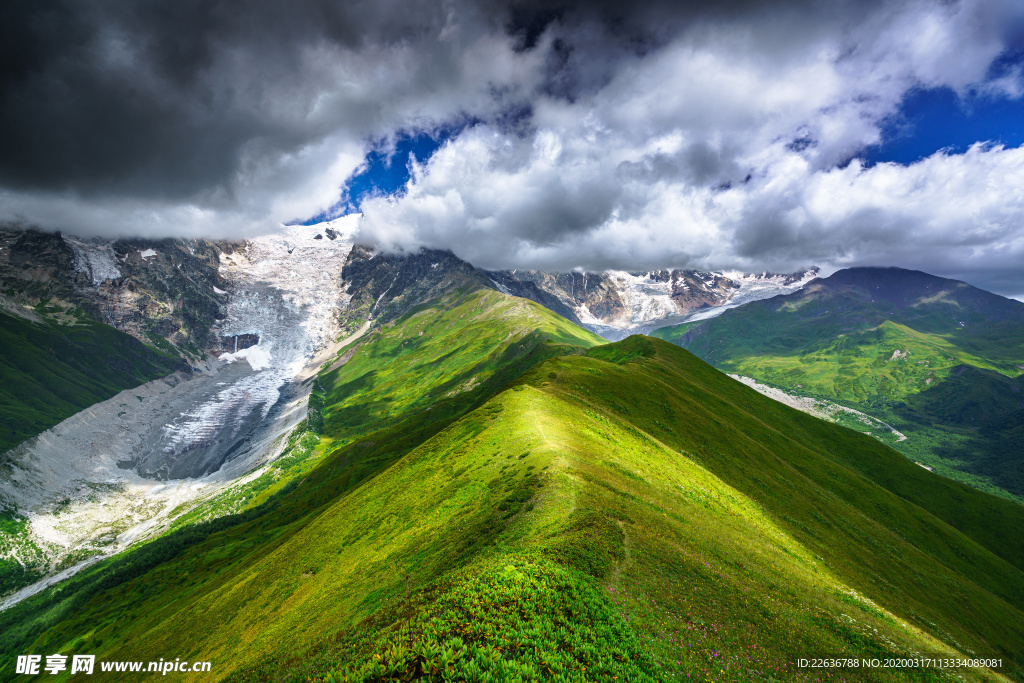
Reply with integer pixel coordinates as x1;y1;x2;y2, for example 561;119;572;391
0;220;1024;681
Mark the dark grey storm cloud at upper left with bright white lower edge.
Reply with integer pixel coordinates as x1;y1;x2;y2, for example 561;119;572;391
0;0;557;234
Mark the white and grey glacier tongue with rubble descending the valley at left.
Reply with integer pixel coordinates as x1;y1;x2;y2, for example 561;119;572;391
0;217;356;608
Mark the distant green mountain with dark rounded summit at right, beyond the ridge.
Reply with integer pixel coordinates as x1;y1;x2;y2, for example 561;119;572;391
652;268;1024;502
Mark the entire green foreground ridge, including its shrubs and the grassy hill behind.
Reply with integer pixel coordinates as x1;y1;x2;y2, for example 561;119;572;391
0;288;1024;681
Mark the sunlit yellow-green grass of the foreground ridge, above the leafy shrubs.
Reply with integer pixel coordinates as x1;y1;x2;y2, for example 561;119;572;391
28;344;991;680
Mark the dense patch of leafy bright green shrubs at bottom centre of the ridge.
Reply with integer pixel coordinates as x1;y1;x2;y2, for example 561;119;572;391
314;558;657;683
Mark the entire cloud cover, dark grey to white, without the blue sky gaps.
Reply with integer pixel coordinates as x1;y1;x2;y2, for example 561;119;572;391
0;0;1024;299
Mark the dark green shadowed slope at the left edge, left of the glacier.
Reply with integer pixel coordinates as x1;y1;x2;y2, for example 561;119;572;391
0;312;183;452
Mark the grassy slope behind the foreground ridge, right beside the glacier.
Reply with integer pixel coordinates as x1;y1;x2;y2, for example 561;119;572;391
162;279;604;526
